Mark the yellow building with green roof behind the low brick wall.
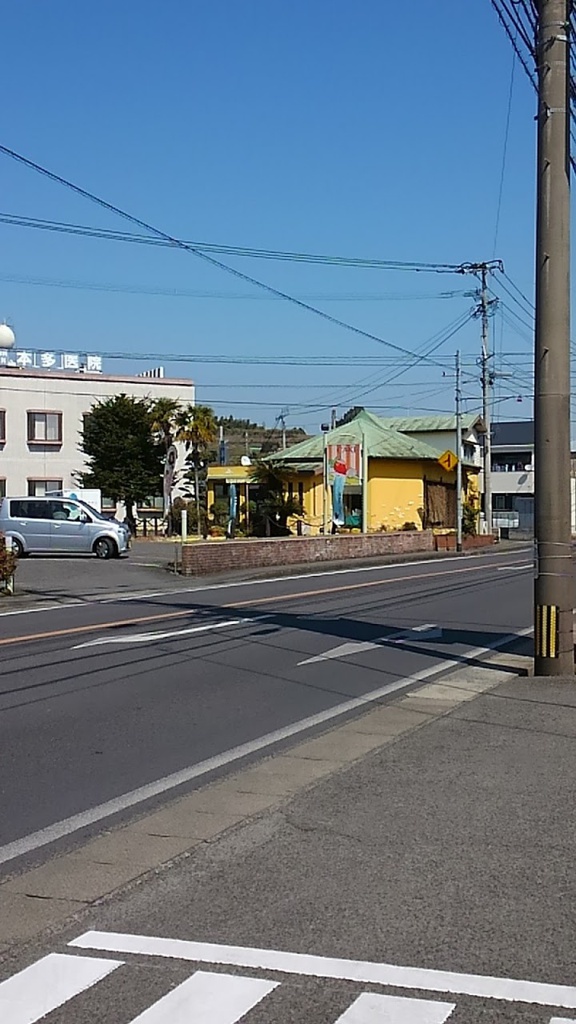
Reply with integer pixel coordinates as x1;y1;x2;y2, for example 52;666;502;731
208;411;479;534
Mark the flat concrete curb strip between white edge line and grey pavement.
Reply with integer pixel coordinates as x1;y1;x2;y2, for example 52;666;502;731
0;652;530;954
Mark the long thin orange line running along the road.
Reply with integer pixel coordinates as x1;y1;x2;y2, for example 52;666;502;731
0;565;528;647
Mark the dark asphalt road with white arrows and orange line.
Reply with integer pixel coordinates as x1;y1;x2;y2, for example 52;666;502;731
0;551;532;868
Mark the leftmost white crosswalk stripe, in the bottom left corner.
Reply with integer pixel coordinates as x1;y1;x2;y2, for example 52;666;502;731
0;953;122;1024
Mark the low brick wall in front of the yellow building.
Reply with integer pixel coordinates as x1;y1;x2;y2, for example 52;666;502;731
182;530;434;575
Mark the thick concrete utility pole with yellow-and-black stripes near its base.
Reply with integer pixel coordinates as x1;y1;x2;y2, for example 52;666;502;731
534;0;574;676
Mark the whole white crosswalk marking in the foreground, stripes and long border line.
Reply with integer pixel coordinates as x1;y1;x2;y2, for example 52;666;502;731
0;932;576;1024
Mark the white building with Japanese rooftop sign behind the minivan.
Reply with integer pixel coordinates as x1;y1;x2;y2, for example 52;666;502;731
0;350;195;507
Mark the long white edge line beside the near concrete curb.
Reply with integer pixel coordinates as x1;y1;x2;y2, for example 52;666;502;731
0;626;532;864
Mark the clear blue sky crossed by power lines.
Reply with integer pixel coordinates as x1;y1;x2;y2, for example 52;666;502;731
0;0;535;430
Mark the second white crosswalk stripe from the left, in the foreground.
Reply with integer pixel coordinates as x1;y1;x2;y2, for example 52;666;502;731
126;971;277;1024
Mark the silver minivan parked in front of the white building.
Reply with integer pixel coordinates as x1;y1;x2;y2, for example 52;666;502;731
0;498;130;558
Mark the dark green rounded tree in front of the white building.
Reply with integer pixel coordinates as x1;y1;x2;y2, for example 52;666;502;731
81;394;165;531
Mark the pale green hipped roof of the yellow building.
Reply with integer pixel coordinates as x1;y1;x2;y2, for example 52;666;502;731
269;410;444;464
